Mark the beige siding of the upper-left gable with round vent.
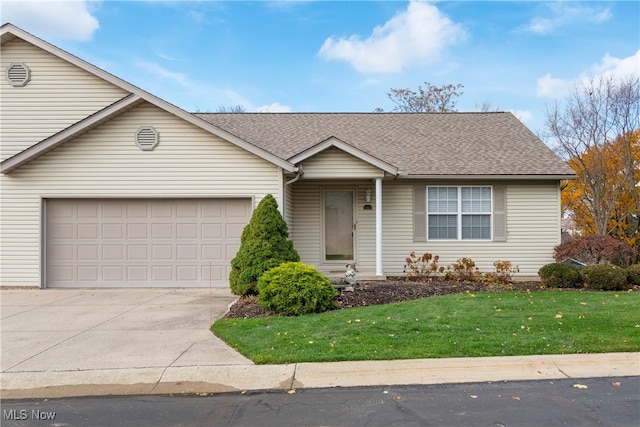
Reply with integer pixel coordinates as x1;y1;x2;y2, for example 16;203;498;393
0;39;128;160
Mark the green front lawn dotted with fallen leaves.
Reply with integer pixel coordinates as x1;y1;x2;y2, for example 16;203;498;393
211;291;640;364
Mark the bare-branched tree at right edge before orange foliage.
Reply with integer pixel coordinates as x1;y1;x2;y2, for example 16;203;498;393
546;76;640;234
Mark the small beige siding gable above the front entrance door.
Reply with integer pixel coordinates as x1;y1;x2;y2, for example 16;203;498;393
302;148;384;179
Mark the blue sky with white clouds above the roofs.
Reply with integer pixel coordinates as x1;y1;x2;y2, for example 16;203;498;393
0;0;640;137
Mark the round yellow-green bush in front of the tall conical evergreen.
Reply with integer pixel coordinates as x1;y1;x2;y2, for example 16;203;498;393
258;262;337;316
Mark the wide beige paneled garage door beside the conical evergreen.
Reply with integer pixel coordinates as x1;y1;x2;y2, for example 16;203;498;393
44;199;251;287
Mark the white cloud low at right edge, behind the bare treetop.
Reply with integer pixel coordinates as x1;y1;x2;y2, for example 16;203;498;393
537;49;640;98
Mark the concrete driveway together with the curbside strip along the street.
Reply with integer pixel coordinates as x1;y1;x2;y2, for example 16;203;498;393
0;289;640;399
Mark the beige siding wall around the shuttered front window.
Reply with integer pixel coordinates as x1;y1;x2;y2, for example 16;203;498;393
383;182;560;276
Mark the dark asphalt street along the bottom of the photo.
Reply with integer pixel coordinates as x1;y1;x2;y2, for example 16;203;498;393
1;376;640;427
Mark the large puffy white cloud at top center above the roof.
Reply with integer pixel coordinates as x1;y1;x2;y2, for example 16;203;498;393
318;0;466;74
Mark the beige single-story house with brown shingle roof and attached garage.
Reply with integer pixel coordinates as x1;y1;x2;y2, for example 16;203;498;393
0;24;574;288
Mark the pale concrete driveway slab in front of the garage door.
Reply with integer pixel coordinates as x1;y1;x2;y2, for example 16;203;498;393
0;289;252;396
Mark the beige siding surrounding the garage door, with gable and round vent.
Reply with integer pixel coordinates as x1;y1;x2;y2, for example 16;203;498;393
0;104;282;286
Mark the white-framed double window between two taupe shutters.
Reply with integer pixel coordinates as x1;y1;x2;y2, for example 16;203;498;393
427;186;493;240
